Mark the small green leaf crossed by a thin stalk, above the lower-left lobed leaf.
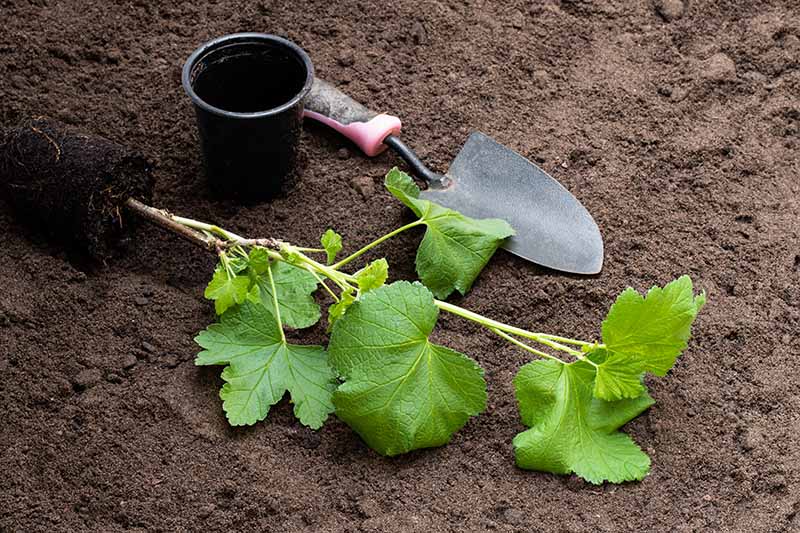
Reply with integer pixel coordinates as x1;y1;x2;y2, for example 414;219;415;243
249;261;320;329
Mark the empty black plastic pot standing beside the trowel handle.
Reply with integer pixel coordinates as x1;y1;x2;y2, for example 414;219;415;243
182;33;314;200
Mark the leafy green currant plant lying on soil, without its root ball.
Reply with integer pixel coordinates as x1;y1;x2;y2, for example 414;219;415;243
169;169;705;483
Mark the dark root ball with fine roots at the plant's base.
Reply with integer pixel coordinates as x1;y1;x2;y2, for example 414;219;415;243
0;118;153;260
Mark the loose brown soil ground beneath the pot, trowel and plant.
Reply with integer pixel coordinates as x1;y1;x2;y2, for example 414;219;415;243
0;0;800;532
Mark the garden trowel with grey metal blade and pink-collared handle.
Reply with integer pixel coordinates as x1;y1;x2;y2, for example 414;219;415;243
305;79;603;274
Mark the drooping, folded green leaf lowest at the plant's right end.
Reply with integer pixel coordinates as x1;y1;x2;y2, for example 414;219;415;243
514;360;654;484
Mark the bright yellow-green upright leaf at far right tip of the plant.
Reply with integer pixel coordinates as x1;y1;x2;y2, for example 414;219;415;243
594;276;706;400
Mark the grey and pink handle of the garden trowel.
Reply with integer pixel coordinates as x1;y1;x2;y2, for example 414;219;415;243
304;79;401;157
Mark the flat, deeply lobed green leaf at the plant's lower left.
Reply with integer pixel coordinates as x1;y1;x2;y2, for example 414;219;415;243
195;302;336;429
